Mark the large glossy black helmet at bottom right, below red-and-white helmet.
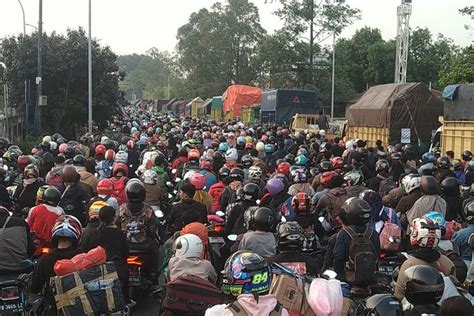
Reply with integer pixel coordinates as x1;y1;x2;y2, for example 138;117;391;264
403;265;444;306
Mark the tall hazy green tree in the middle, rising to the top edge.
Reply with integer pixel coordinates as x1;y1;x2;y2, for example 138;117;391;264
177;0;266;97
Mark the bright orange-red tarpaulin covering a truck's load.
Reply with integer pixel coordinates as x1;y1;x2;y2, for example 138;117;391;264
222;85;262;117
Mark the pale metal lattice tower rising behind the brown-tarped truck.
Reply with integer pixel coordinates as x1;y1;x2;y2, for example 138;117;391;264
395;0;411;83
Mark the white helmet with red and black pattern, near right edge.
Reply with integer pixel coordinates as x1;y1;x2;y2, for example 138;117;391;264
410;217;441;248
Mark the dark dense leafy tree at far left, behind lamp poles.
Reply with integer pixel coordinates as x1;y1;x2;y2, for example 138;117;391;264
1;29;123;137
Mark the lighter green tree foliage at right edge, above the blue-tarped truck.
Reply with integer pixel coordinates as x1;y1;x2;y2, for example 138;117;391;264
439;45;474;88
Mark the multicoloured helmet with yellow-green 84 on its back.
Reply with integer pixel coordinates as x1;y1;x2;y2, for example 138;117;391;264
224;250;271;296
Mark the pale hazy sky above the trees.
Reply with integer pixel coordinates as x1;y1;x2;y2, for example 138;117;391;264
0;0;474;54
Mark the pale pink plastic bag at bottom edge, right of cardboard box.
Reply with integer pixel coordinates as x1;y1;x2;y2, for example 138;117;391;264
307;279;343;316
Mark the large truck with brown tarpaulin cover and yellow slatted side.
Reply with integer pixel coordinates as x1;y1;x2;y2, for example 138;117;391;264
346;82;443;152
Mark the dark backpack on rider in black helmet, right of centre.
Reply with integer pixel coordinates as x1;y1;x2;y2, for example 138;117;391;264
343;227;377;285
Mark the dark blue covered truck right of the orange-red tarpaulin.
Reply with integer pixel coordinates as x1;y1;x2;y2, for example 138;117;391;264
260;89;317;124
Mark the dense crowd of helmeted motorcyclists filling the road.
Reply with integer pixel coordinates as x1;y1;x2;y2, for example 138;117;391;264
0;108;474;315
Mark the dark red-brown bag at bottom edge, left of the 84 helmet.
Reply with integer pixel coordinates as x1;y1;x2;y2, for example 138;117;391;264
162;275;226;315
